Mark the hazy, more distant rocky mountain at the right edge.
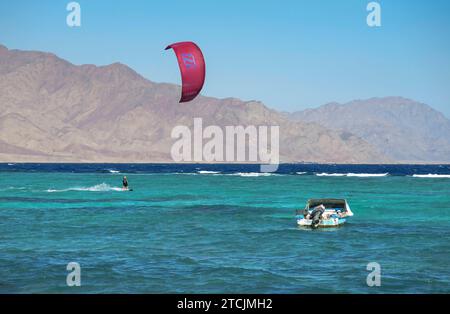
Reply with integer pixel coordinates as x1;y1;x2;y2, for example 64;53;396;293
290;97;450;163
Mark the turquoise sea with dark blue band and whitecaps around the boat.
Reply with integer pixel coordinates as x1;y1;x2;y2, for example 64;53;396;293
0;164;450;293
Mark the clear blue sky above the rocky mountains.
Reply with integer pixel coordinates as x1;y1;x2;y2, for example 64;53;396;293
0;0;450;116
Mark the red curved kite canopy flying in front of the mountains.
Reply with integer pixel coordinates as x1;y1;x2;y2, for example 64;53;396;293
166;41;205;102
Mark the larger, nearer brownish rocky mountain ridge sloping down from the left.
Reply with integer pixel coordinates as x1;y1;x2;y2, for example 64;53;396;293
0;46;392;163
